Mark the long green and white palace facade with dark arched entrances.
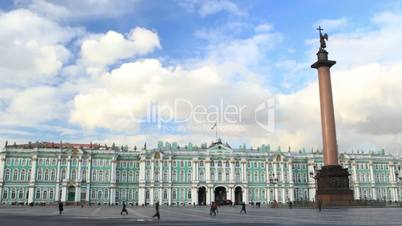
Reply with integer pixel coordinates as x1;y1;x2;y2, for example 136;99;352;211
0;141;402;205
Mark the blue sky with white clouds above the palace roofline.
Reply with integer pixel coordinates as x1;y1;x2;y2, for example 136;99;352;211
0;0;402;155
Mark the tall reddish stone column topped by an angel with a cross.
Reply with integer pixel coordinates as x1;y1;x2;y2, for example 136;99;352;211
311;27;353;206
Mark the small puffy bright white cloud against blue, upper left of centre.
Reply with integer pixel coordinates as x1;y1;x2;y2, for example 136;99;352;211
81;27;160;67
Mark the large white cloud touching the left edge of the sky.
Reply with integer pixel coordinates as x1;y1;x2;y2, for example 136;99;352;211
0;10;79;87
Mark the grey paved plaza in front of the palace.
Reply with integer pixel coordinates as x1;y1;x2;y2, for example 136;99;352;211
0;207;402;226
